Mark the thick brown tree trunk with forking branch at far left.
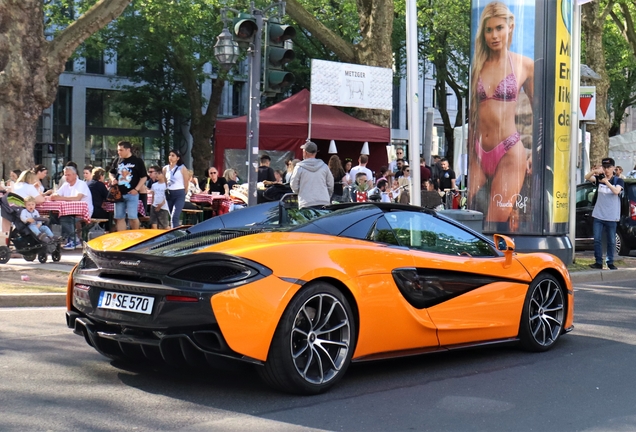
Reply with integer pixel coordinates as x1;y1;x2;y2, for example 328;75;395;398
0;0;130;174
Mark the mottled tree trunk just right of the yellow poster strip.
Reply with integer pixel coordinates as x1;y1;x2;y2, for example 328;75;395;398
581;2;611;165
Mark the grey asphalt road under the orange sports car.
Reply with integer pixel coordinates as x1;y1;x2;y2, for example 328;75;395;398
0;281;636;431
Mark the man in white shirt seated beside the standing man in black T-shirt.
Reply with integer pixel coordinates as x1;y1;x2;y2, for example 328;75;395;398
51;166;93;250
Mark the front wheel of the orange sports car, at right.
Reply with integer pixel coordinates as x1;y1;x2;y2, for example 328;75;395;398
519;273;565;352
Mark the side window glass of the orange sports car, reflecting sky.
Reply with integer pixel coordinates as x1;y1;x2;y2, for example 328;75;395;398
385;211;495;256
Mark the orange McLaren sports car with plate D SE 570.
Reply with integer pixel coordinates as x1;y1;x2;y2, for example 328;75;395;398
66;203;574;394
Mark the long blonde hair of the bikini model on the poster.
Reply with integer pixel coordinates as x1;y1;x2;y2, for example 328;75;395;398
469;1;515;146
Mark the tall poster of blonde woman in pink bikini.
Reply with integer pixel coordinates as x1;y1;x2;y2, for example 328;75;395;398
468;0;543;234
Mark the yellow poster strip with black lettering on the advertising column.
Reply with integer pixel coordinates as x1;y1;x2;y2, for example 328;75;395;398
552;0;572;223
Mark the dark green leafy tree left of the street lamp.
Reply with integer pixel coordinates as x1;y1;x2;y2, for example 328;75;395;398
102;0;231;175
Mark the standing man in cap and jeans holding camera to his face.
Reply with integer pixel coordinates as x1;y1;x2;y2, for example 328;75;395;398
585;158;625;270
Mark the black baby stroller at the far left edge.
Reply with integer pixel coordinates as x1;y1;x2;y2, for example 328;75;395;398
0;193;62;264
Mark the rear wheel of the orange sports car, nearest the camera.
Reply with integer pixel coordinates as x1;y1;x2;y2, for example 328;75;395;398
258;282;356;395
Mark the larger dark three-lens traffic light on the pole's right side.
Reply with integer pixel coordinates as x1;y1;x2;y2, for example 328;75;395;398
263;20;296;93
